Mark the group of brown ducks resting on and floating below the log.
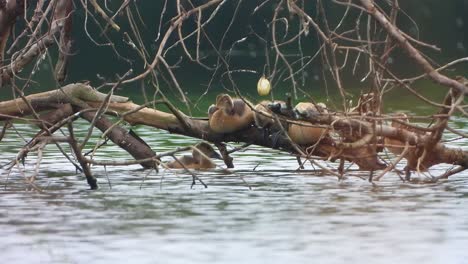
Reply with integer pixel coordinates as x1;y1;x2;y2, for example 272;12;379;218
166;94;327;169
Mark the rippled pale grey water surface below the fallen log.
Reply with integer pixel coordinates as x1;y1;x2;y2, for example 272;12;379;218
0;120;468;263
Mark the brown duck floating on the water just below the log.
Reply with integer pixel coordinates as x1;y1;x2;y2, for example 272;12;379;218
166;142;222;169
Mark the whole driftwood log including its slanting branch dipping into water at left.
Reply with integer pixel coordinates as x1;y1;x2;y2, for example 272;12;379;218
0;83;468;187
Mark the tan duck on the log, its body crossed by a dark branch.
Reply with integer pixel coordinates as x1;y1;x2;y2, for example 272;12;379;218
288;103;327;145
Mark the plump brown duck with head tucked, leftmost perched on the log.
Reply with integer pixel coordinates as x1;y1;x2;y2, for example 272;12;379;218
208;94;254;133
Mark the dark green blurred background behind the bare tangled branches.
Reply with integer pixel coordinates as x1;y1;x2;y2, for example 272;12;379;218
2;0;468;114
